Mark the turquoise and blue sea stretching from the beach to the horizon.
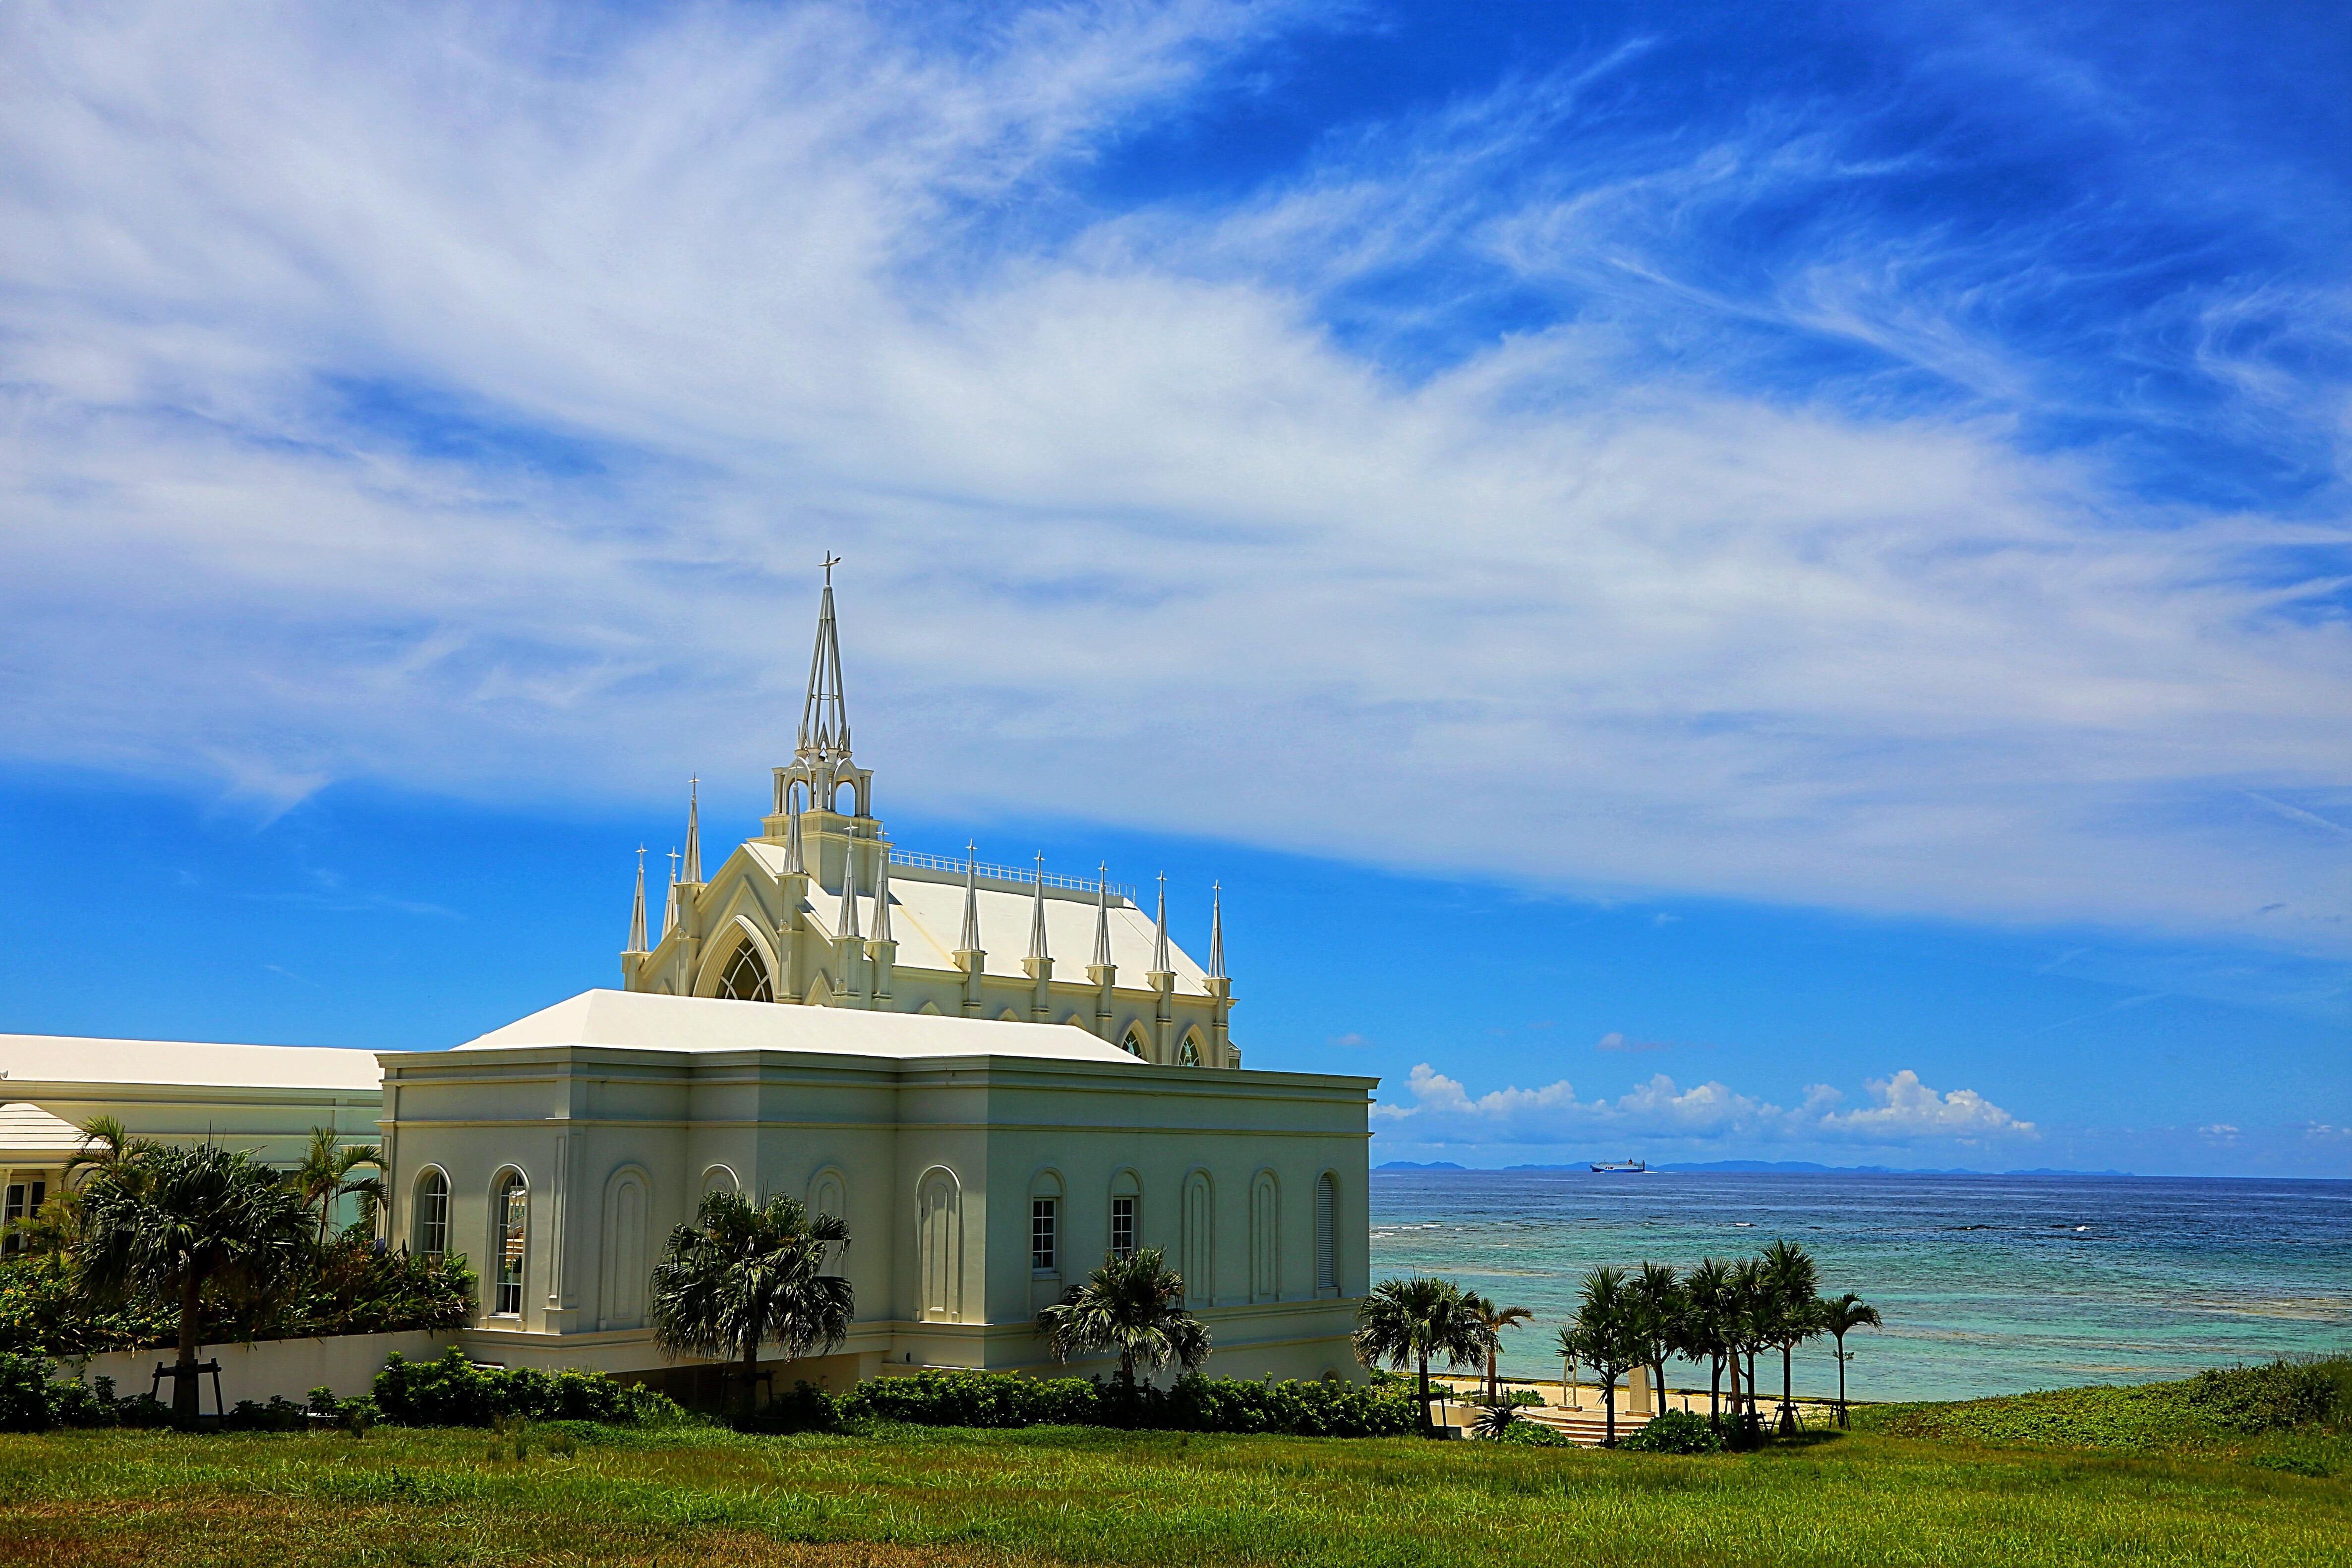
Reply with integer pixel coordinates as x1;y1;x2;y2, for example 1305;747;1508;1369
1371;1171;2352;1399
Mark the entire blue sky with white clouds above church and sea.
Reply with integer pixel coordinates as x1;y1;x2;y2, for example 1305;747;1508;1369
0;4;2352;1175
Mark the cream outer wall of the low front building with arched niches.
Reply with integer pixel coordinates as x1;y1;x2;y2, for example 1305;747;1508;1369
383;1046;1371;1380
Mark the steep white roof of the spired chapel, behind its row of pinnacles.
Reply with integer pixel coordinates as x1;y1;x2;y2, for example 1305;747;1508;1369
743;839;1209;997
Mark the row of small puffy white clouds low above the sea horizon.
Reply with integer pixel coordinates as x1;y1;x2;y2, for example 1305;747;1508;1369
1371;1062;2039;1150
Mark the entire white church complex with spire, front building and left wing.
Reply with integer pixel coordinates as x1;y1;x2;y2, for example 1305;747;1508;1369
0;571;1376;1392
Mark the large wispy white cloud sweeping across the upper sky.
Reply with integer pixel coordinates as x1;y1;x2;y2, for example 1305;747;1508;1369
0;2;2352;949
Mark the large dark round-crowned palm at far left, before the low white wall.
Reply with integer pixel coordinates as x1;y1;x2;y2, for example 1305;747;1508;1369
75;1143;310;1420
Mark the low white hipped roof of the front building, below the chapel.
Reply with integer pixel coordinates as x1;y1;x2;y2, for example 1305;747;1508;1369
459;989;1141;1067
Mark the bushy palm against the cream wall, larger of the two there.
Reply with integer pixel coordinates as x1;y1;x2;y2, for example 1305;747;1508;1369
651;1192;854;1415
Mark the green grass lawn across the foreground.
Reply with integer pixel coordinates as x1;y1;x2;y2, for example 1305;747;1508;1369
0;1422;2352;1568
